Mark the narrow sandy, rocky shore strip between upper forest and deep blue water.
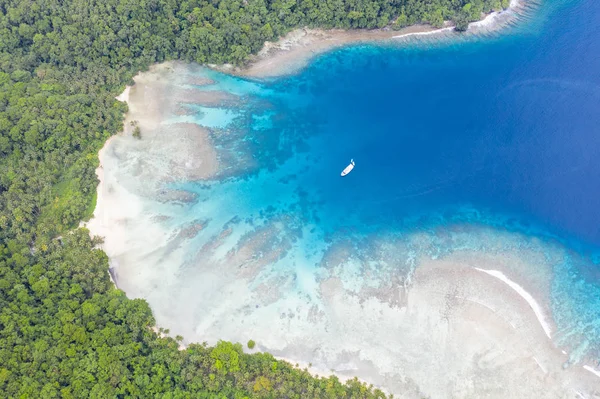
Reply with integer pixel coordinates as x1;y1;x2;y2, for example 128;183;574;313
218;0;525;79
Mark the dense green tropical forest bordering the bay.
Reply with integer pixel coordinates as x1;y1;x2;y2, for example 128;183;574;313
0;0;508;398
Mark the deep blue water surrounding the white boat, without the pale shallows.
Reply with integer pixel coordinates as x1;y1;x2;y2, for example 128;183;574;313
255;0;600;247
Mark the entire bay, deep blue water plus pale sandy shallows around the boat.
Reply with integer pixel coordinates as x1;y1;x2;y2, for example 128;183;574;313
89;0;600;397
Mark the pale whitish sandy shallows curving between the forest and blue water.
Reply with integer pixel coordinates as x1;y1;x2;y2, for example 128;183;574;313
87;6;600;398
